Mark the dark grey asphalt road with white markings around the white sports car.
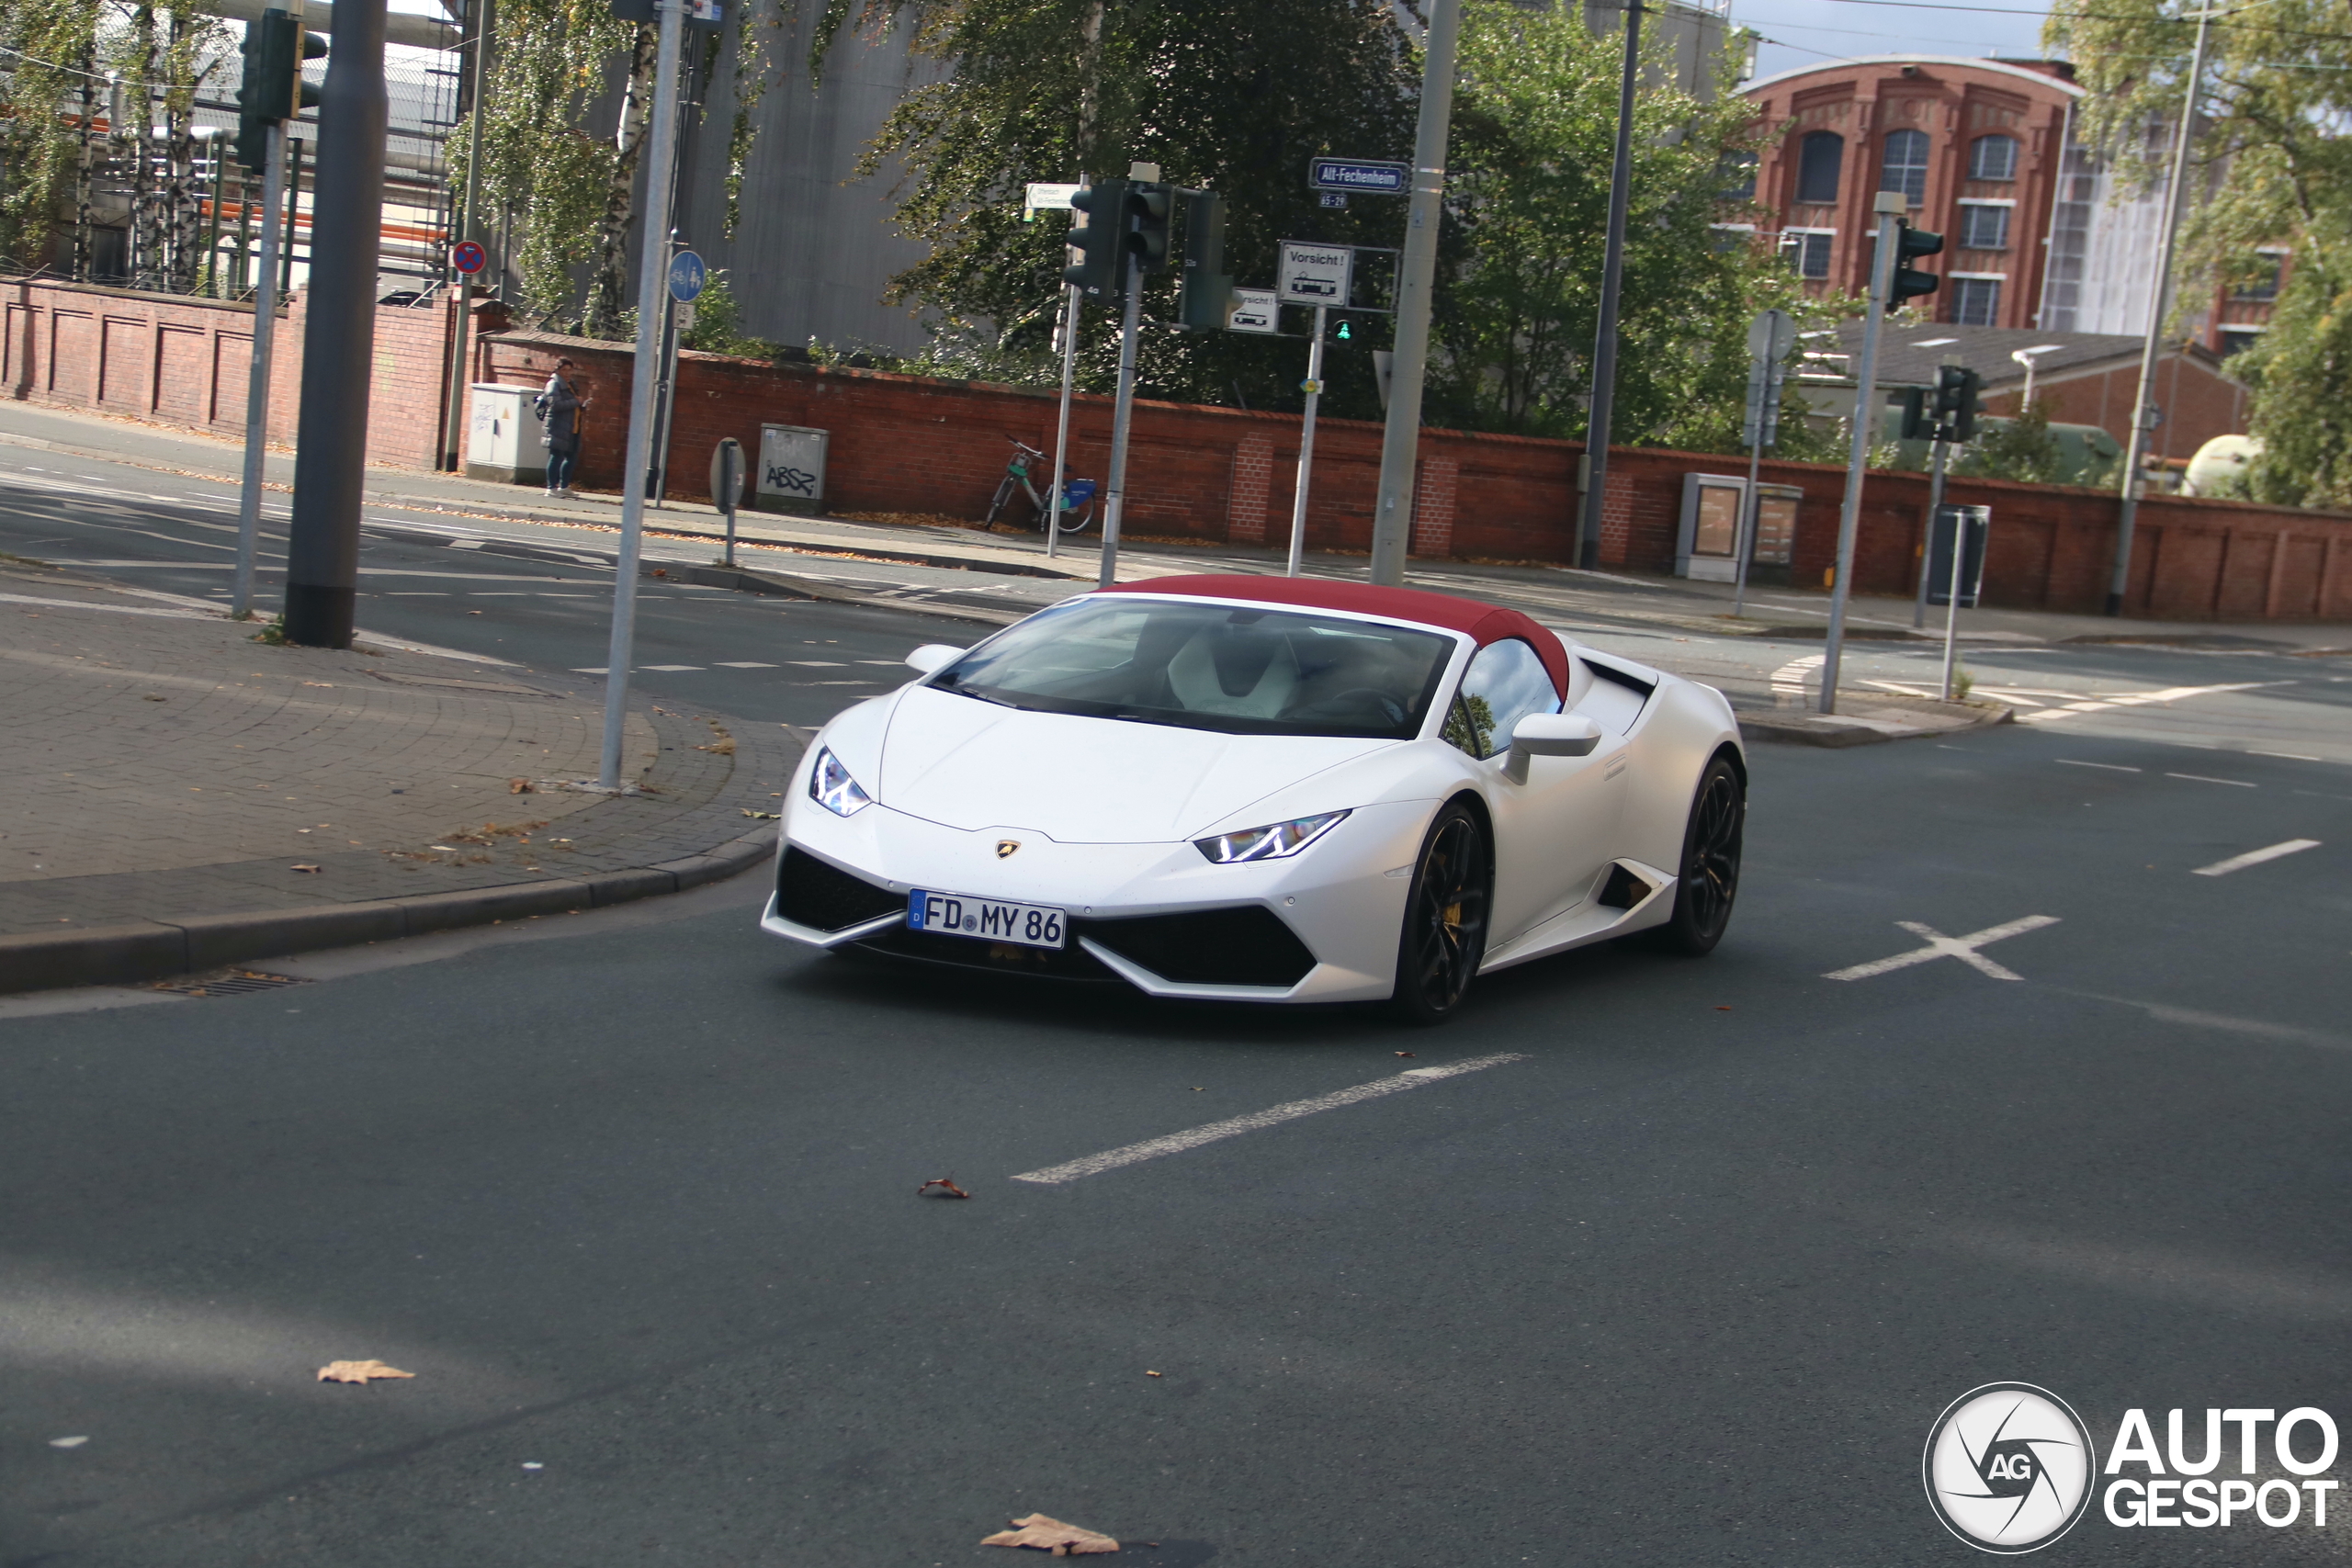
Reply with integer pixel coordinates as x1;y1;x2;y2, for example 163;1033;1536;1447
0;439;2352;1568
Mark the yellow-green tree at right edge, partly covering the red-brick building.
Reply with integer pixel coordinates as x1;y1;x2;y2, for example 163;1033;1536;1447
2044;0;2352;505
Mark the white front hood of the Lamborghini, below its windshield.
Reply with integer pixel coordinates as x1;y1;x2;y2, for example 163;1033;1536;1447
875;686;1397;844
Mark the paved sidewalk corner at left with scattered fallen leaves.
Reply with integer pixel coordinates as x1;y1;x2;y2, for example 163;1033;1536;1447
0;554;802;992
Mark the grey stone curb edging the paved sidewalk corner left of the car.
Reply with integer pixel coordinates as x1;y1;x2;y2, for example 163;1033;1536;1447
0;828;776;995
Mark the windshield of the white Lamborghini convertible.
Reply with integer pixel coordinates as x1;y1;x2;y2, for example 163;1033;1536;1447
932;597;1453;740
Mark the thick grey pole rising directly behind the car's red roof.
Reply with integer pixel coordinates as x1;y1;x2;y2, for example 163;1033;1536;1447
1374;0;1463;585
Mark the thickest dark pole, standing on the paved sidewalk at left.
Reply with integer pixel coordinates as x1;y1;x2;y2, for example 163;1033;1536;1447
287;0;390;649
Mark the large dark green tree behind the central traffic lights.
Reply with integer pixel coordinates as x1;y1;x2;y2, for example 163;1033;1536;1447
837;0;1414;416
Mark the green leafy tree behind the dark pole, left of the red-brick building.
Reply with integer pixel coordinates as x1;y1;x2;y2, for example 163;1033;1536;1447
1430;0;1837;451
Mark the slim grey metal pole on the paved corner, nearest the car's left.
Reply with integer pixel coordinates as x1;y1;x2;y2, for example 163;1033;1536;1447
597;0;684;790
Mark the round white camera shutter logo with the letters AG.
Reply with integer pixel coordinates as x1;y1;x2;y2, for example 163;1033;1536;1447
1919;1382;2098;1556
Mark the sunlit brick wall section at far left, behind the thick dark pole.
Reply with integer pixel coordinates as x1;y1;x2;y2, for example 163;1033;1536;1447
0;277;449;468
